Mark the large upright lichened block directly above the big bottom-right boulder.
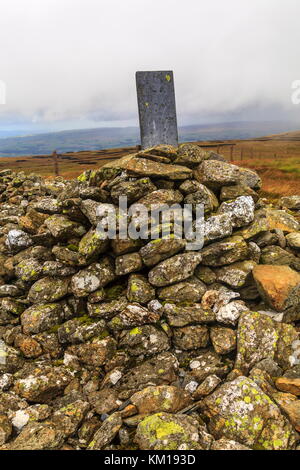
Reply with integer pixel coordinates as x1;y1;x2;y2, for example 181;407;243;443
235;312;298;373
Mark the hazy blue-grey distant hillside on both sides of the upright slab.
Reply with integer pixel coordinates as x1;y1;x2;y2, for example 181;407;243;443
0;121;297;157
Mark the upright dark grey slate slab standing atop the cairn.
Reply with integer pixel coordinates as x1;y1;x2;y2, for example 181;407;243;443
136;71;178;149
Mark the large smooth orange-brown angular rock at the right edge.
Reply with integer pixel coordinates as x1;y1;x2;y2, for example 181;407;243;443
252;265;300;312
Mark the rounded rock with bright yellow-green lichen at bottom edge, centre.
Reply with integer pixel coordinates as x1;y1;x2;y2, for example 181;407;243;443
135;413;202;450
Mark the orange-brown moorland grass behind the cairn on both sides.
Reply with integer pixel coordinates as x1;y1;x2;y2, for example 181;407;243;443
0;138;300;197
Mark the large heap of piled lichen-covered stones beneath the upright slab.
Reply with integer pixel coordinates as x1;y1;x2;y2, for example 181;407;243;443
0;144;300;450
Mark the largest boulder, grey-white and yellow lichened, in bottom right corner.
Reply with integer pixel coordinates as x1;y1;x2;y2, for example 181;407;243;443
201;377;295;450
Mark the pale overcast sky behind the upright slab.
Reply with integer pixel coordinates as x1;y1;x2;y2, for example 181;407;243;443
0;0;300;129
